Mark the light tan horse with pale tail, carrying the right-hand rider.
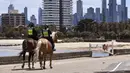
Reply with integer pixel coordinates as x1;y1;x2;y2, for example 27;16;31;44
36;32;57;69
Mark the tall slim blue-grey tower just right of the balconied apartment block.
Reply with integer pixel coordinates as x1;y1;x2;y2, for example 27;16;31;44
77;0;83;21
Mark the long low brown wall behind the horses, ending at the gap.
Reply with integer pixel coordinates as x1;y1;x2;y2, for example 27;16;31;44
0;51;92;65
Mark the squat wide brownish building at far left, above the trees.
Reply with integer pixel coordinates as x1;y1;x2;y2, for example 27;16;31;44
1;13;25;31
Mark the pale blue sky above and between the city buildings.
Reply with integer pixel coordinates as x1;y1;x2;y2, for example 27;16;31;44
0;0;130;20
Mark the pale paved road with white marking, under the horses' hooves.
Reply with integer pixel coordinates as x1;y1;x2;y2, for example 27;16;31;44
0;55;130;73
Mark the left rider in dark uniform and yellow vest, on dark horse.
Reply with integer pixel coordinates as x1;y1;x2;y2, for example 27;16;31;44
28;22;38;41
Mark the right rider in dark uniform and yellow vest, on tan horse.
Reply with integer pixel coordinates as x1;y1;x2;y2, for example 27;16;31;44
42;26;56;51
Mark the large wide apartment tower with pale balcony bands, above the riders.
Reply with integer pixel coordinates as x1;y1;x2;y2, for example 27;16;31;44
42;0;72;27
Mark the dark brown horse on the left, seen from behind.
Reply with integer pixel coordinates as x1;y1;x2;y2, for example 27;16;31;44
19;39;37;69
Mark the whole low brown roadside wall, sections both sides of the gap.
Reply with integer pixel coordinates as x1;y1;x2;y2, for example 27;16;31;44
0;49;130;65
